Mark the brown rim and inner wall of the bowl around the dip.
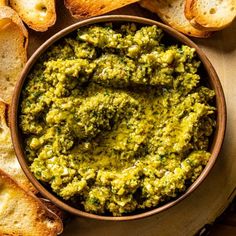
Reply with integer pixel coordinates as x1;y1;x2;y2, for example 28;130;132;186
10;15;226;221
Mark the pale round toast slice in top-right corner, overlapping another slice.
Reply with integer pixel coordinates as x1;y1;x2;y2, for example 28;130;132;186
185;0;236;31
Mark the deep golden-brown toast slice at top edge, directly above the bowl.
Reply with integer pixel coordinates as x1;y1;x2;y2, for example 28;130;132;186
64;0;139;18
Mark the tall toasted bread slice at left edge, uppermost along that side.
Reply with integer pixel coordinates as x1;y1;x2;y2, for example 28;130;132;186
0;6;28;103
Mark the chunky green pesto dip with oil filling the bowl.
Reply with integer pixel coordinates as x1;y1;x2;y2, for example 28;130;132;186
19;23;215;216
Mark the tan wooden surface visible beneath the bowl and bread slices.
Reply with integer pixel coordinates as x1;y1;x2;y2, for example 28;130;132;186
29;4;236;236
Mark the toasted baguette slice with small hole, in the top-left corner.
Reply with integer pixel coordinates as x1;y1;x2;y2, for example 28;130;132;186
9;0;56;31
